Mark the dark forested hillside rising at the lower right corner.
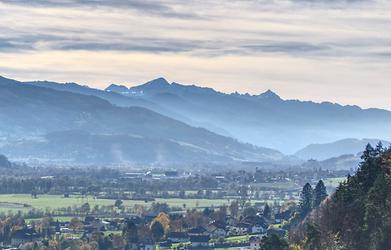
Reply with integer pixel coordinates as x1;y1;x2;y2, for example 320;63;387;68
290;144;391;250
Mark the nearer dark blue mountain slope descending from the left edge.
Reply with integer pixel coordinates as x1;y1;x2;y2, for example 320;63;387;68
0;78;283;164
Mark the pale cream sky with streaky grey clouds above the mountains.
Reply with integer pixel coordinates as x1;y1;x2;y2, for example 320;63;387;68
0;0;391;110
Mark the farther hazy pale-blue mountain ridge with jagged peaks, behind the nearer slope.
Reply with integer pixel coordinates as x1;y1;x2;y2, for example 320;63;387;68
109;78;391;153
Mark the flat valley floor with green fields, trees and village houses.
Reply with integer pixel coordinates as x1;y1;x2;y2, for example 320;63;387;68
0;157;349;250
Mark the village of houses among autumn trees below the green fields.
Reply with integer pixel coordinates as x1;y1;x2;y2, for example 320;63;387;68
1;197;295;250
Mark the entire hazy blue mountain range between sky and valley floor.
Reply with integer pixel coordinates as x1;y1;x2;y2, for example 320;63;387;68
0;74;391;167
